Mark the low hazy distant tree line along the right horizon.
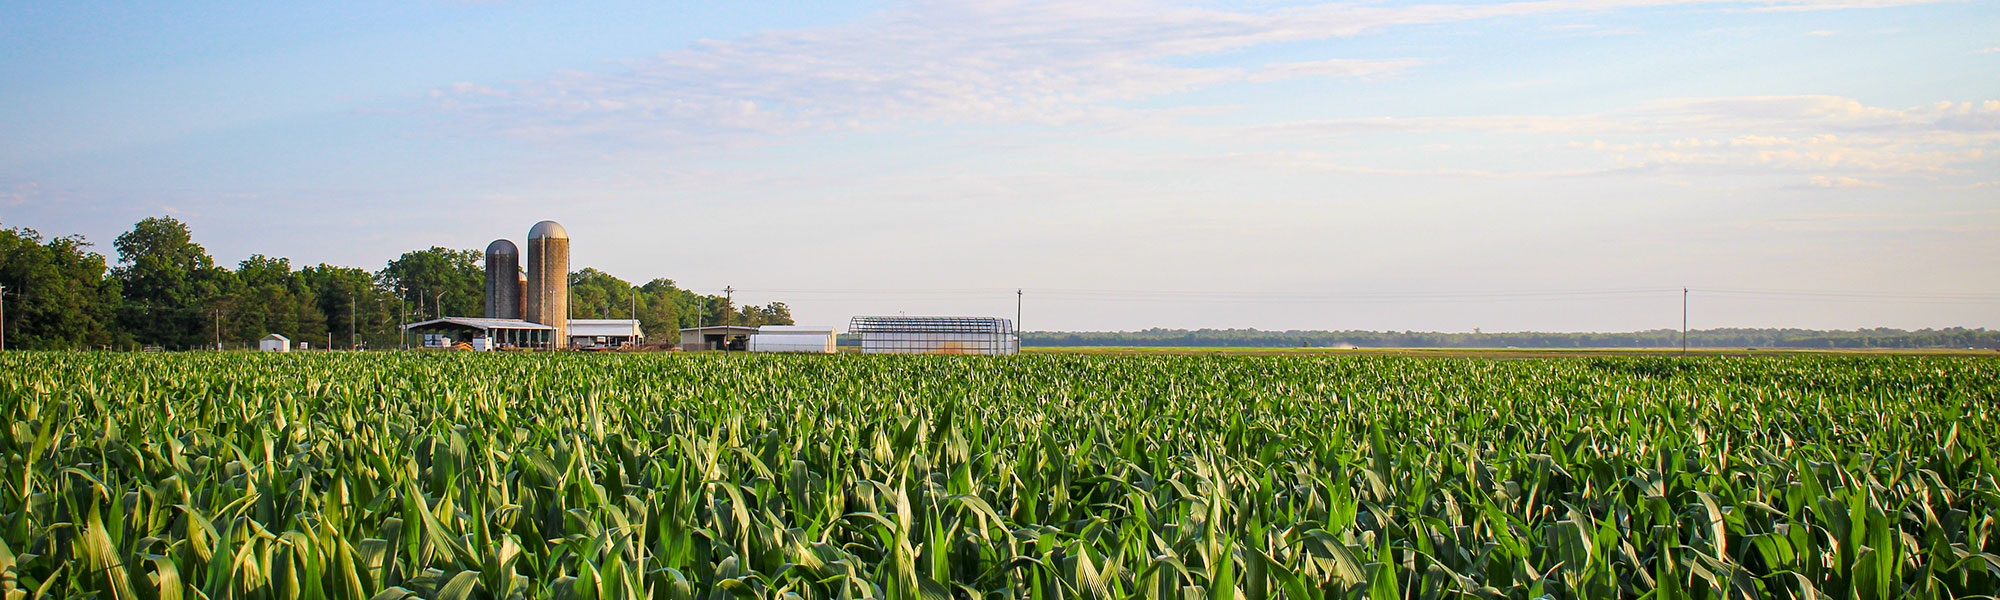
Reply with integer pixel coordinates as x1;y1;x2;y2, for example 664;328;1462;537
1022;328;2000;350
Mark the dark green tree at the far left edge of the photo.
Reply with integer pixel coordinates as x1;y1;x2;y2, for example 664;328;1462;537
0;228;124;350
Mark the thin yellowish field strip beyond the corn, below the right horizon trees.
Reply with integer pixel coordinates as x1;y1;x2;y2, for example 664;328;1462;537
1022;346;2000;358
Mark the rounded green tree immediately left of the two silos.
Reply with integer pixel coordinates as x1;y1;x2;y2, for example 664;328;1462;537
376;246;486;322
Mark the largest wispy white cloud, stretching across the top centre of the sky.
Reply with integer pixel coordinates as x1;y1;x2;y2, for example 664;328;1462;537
432;0;1936;146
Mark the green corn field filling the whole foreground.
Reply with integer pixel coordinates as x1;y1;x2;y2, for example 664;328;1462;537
0;352;2000;600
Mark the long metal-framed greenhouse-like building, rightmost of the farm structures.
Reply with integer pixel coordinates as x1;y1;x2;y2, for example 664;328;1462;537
848;316;1020;354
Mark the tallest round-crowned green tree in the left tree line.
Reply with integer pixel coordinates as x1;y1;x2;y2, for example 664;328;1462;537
112;216;234;348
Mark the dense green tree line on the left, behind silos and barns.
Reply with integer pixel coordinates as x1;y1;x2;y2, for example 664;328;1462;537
0;216;792;350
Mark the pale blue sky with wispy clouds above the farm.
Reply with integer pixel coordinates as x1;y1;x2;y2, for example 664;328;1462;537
0;0;2000;332
